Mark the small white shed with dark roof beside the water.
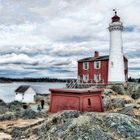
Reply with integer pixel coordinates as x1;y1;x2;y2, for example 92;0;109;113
15;85;36;103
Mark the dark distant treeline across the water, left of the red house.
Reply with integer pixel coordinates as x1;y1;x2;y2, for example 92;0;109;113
0;77;75;83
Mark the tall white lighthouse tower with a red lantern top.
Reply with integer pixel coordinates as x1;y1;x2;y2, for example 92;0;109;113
108;10;125;83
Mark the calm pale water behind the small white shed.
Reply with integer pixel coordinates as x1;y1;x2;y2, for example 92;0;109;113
0;82;65;102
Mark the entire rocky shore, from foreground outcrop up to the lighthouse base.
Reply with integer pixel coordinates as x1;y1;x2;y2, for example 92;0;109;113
0;84;140;140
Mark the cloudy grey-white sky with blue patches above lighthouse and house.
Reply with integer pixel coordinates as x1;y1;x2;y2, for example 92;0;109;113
0;0;140;78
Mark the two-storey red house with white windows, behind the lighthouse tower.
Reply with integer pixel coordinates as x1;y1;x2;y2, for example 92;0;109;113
78;51;128;83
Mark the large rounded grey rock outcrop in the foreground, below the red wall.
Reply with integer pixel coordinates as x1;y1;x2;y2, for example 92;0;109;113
12;111;140;140
